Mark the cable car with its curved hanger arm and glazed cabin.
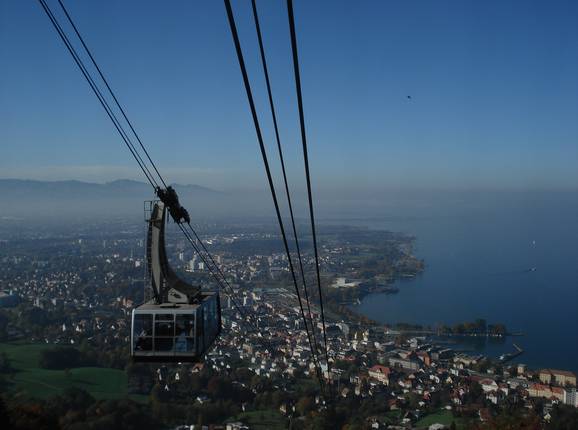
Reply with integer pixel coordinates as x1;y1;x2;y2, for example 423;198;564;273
131;202;221;362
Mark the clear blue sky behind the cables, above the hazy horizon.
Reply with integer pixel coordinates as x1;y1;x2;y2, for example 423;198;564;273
0;0;578;190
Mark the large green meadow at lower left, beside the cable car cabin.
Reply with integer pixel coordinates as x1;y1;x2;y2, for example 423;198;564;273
0;343;146;401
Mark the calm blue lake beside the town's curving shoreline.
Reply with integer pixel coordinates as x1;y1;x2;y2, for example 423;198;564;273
322;192;578;371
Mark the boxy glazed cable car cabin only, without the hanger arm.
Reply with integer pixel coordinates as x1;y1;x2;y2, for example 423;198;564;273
131;293;221;362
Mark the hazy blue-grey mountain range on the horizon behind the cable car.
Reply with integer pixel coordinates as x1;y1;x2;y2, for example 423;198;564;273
0;179;262;219
